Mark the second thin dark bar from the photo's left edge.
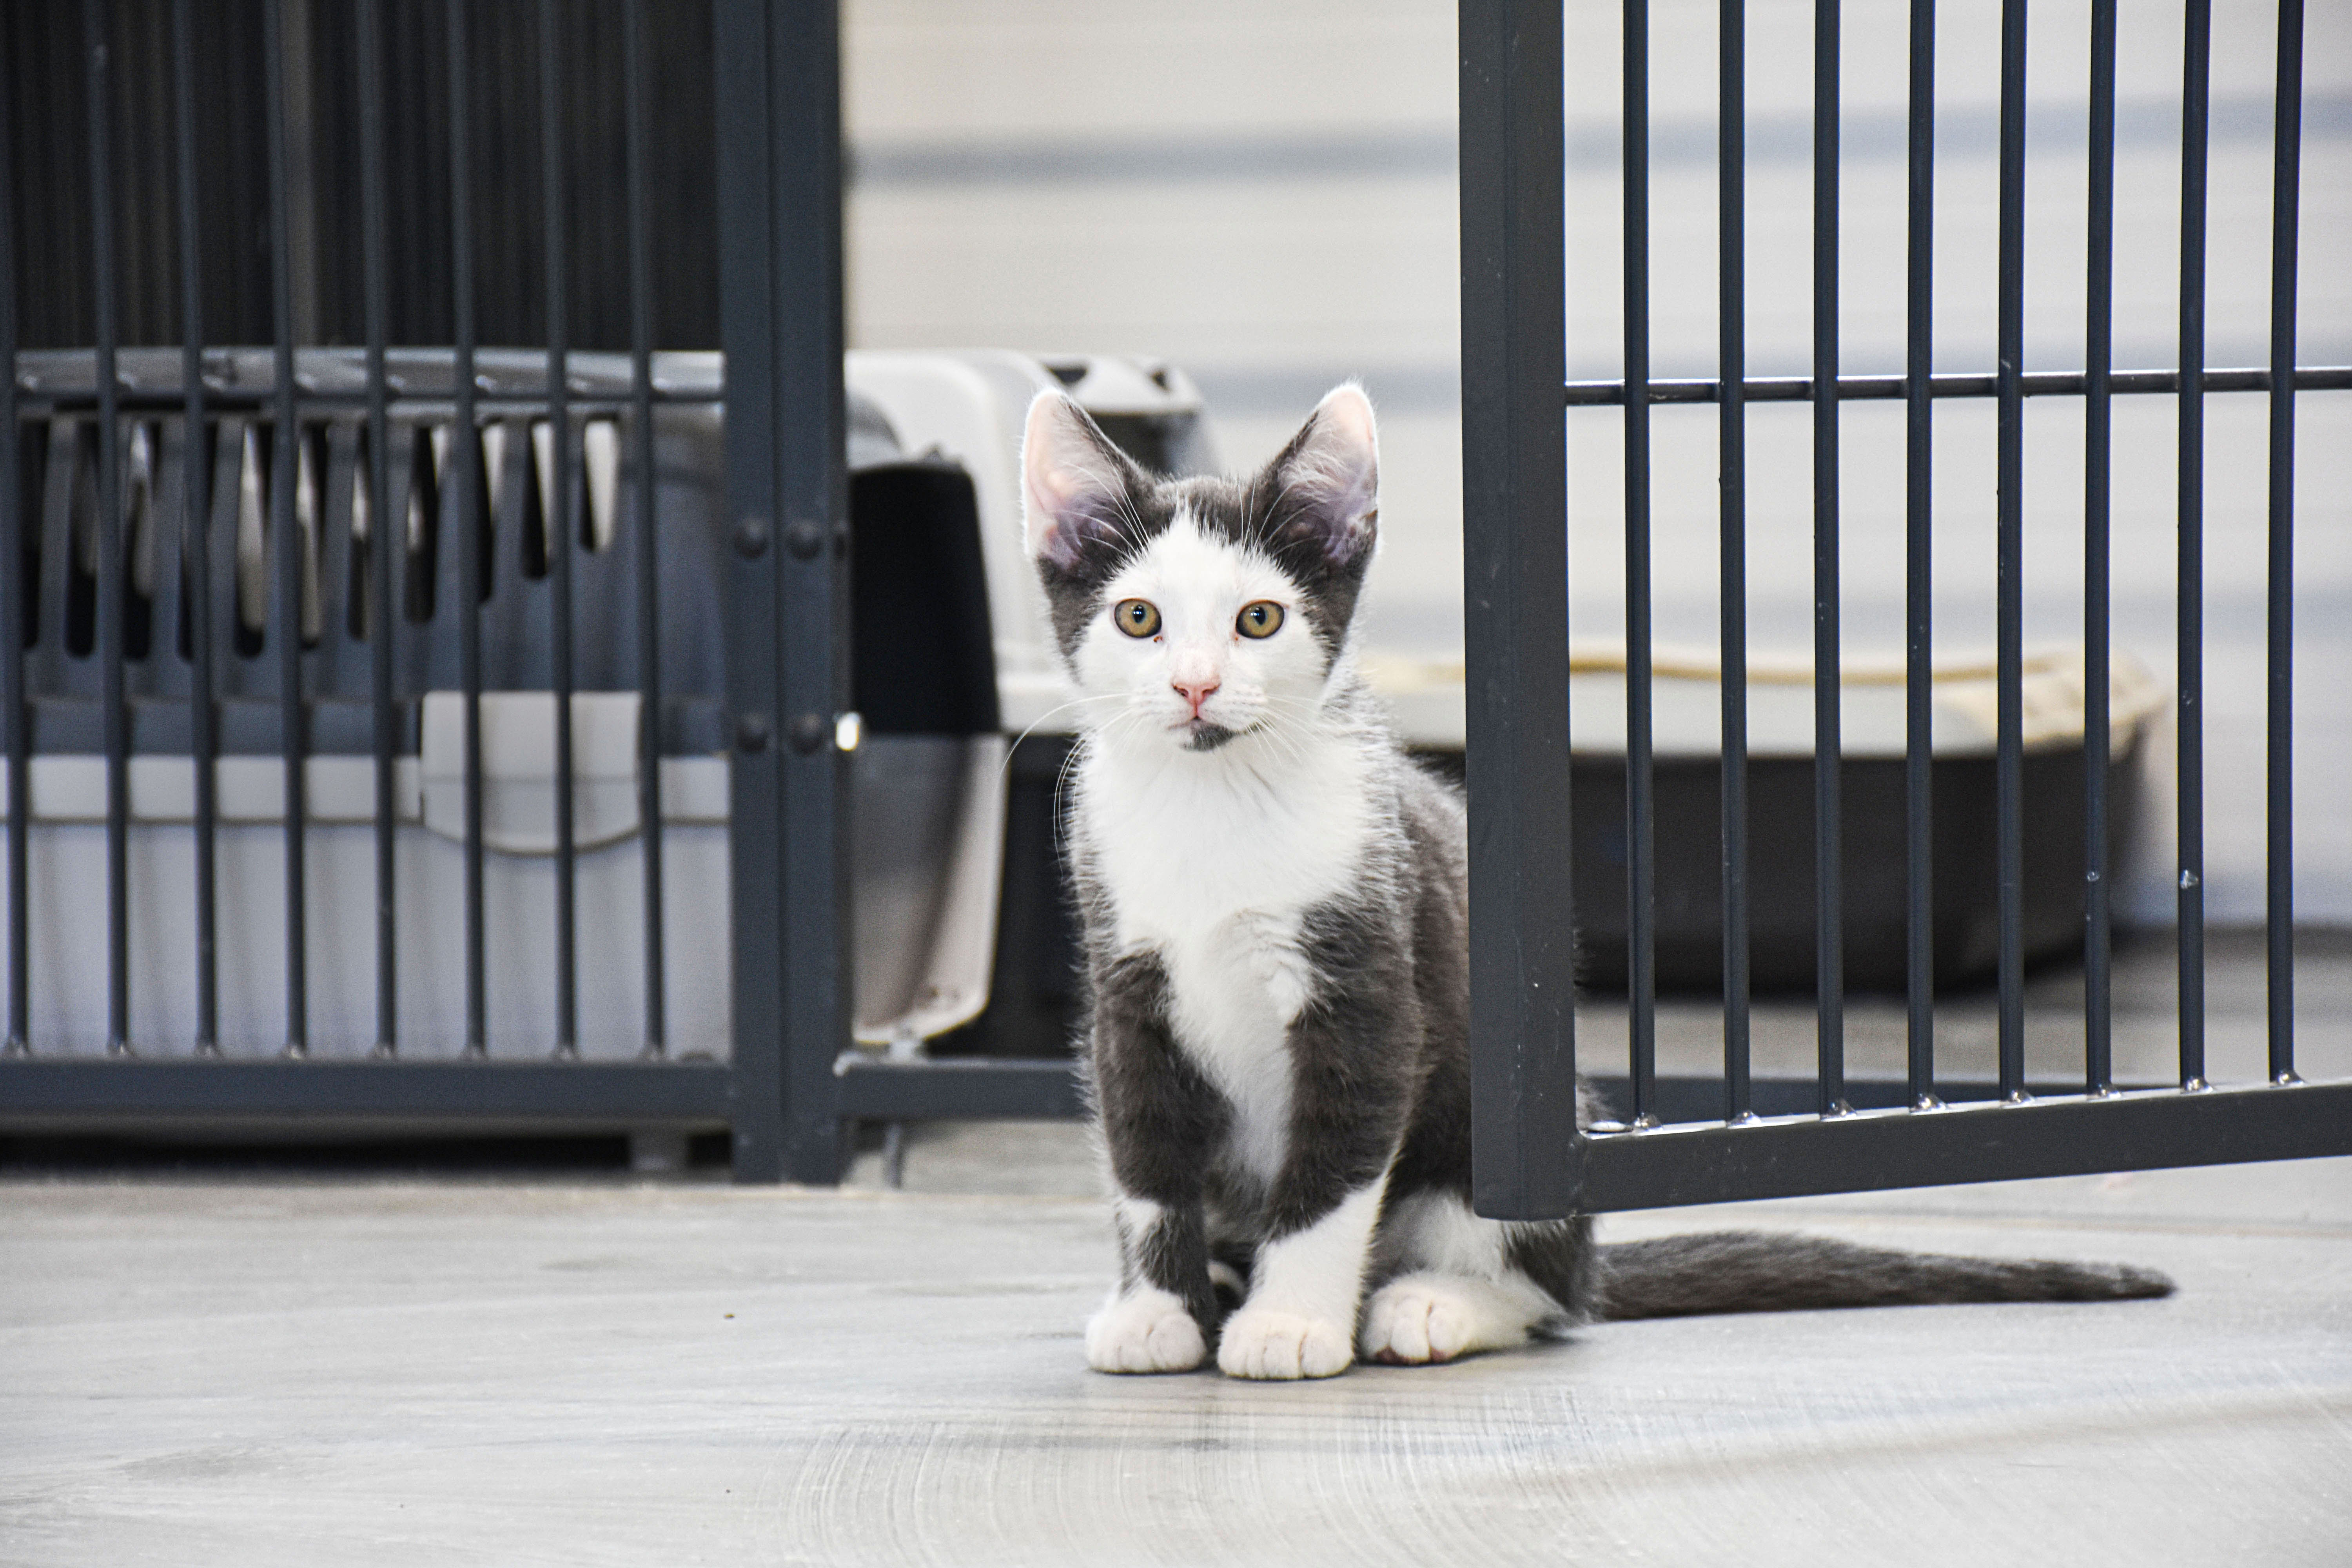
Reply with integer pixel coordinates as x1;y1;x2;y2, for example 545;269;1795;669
86;0;132;1056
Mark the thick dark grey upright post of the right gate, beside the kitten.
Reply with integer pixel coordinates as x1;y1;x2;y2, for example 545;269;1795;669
1458;0;1583;1220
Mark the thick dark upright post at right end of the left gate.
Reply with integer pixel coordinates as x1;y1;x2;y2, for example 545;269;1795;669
713;0;849;1180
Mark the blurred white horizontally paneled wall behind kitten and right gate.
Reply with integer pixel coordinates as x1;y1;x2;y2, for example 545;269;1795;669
844;0;2352;924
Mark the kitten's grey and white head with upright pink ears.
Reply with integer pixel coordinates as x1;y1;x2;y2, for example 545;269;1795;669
1021;386;1381;752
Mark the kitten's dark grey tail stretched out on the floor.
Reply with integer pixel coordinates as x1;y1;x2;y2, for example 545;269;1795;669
1595;1229;2173;1321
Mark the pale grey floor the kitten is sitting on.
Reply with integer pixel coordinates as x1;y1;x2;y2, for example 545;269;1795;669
0;1124;2352;1568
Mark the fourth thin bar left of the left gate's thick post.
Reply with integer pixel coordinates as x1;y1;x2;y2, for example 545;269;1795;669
358;0;393;1058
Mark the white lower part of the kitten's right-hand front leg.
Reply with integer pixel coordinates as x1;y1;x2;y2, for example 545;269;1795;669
1216;1176;1388;1377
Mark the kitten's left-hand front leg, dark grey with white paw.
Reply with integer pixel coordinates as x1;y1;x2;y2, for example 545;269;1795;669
1087;955;1230;1373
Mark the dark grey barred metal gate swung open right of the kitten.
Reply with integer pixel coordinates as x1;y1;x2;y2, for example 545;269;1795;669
1461;0;2352;1218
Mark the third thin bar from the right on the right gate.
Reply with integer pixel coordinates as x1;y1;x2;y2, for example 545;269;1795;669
2082;0;2114;1096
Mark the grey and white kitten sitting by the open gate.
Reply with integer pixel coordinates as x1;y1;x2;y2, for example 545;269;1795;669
1023;386;2171;1377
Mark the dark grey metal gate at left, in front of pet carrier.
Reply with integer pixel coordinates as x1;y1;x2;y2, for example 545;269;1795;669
0;0;946;1180
